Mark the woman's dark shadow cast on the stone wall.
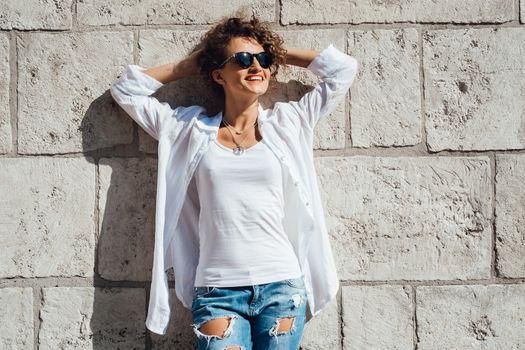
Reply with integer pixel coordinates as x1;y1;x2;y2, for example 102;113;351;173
80;72;313;350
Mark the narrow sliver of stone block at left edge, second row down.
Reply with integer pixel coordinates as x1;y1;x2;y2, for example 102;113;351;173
0;34;12;154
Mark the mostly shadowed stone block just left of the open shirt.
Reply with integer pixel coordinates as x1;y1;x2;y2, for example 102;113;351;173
97;158;157;281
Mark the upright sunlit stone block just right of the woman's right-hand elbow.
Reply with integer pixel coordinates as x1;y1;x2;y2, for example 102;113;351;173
348;29;421;147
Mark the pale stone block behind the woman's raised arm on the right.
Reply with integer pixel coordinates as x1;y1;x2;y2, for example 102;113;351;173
261;29;347;149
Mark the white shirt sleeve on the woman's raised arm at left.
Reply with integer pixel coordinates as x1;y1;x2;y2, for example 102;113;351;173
110;65;174;140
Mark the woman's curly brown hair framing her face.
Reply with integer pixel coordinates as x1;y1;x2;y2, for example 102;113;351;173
197;14;286;96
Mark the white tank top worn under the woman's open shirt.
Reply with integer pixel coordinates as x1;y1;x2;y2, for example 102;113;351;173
194;135;302;287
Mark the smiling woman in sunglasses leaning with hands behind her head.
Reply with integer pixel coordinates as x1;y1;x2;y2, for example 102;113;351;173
111;17;357;349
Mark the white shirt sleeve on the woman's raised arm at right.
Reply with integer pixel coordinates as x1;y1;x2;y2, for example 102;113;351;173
292;45;358;129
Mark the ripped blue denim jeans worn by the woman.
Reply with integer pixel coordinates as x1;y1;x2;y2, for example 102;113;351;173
191;277;307;350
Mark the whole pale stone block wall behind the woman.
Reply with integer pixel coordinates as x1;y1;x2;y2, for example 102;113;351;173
0;0;525;350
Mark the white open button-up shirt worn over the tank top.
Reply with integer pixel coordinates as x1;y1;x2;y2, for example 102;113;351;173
110;45;358;334
